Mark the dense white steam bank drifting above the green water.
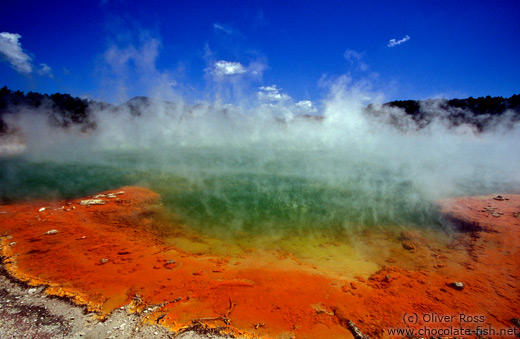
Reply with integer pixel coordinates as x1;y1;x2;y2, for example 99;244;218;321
8;77;520;205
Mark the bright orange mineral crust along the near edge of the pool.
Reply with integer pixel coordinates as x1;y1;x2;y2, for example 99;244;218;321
0;187;520;338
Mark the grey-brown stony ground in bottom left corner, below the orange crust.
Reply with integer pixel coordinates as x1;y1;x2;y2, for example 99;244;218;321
0;263;217;339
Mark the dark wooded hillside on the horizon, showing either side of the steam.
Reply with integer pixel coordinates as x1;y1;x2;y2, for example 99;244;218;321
0;87;520;135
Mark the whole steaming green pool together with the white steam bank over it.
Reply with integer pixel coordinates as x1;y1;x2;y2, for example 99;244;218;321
0;89;520;243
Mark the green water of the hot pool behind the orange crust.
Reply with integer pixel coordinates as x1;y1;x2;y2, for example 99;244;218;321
0;148;444;238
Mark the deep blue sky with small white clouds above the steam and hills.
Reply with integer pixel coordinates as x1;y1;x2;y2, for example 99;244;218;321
0;0;520;103
